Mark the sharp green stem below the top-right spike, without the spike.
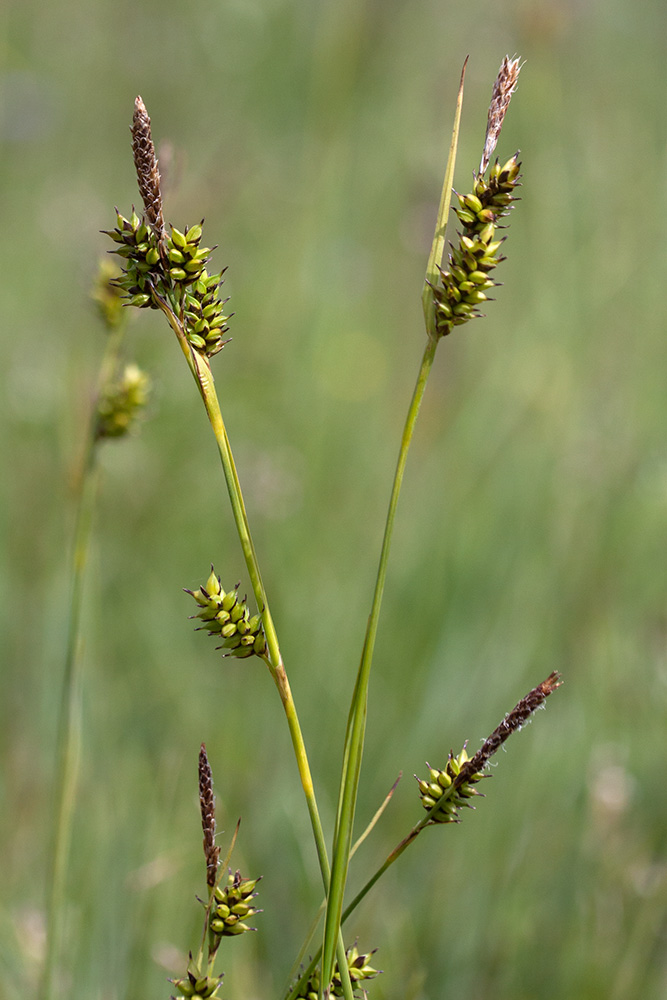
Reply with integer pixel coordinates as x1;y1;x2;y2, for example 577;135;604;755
322;337;438;983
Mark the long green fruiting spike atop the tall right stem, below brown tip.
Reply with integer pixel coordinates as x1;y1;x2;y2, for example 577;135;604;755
433;153;521;337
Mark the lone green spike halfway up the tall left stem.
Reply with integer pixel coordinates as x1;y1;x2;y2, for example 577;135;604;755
185;566;266;659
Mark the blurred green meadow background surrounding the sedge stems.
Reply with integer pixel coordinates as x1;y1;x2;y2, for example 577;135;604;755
0;0;667;1000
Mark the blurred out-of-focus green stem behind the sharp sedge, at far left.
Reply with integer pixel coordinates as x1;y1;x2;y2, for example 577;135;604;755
40;327;124;1000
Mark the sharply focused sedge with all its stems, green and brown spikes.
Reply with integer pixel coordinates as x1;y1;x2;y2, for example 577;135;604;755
48;57;560;1000
